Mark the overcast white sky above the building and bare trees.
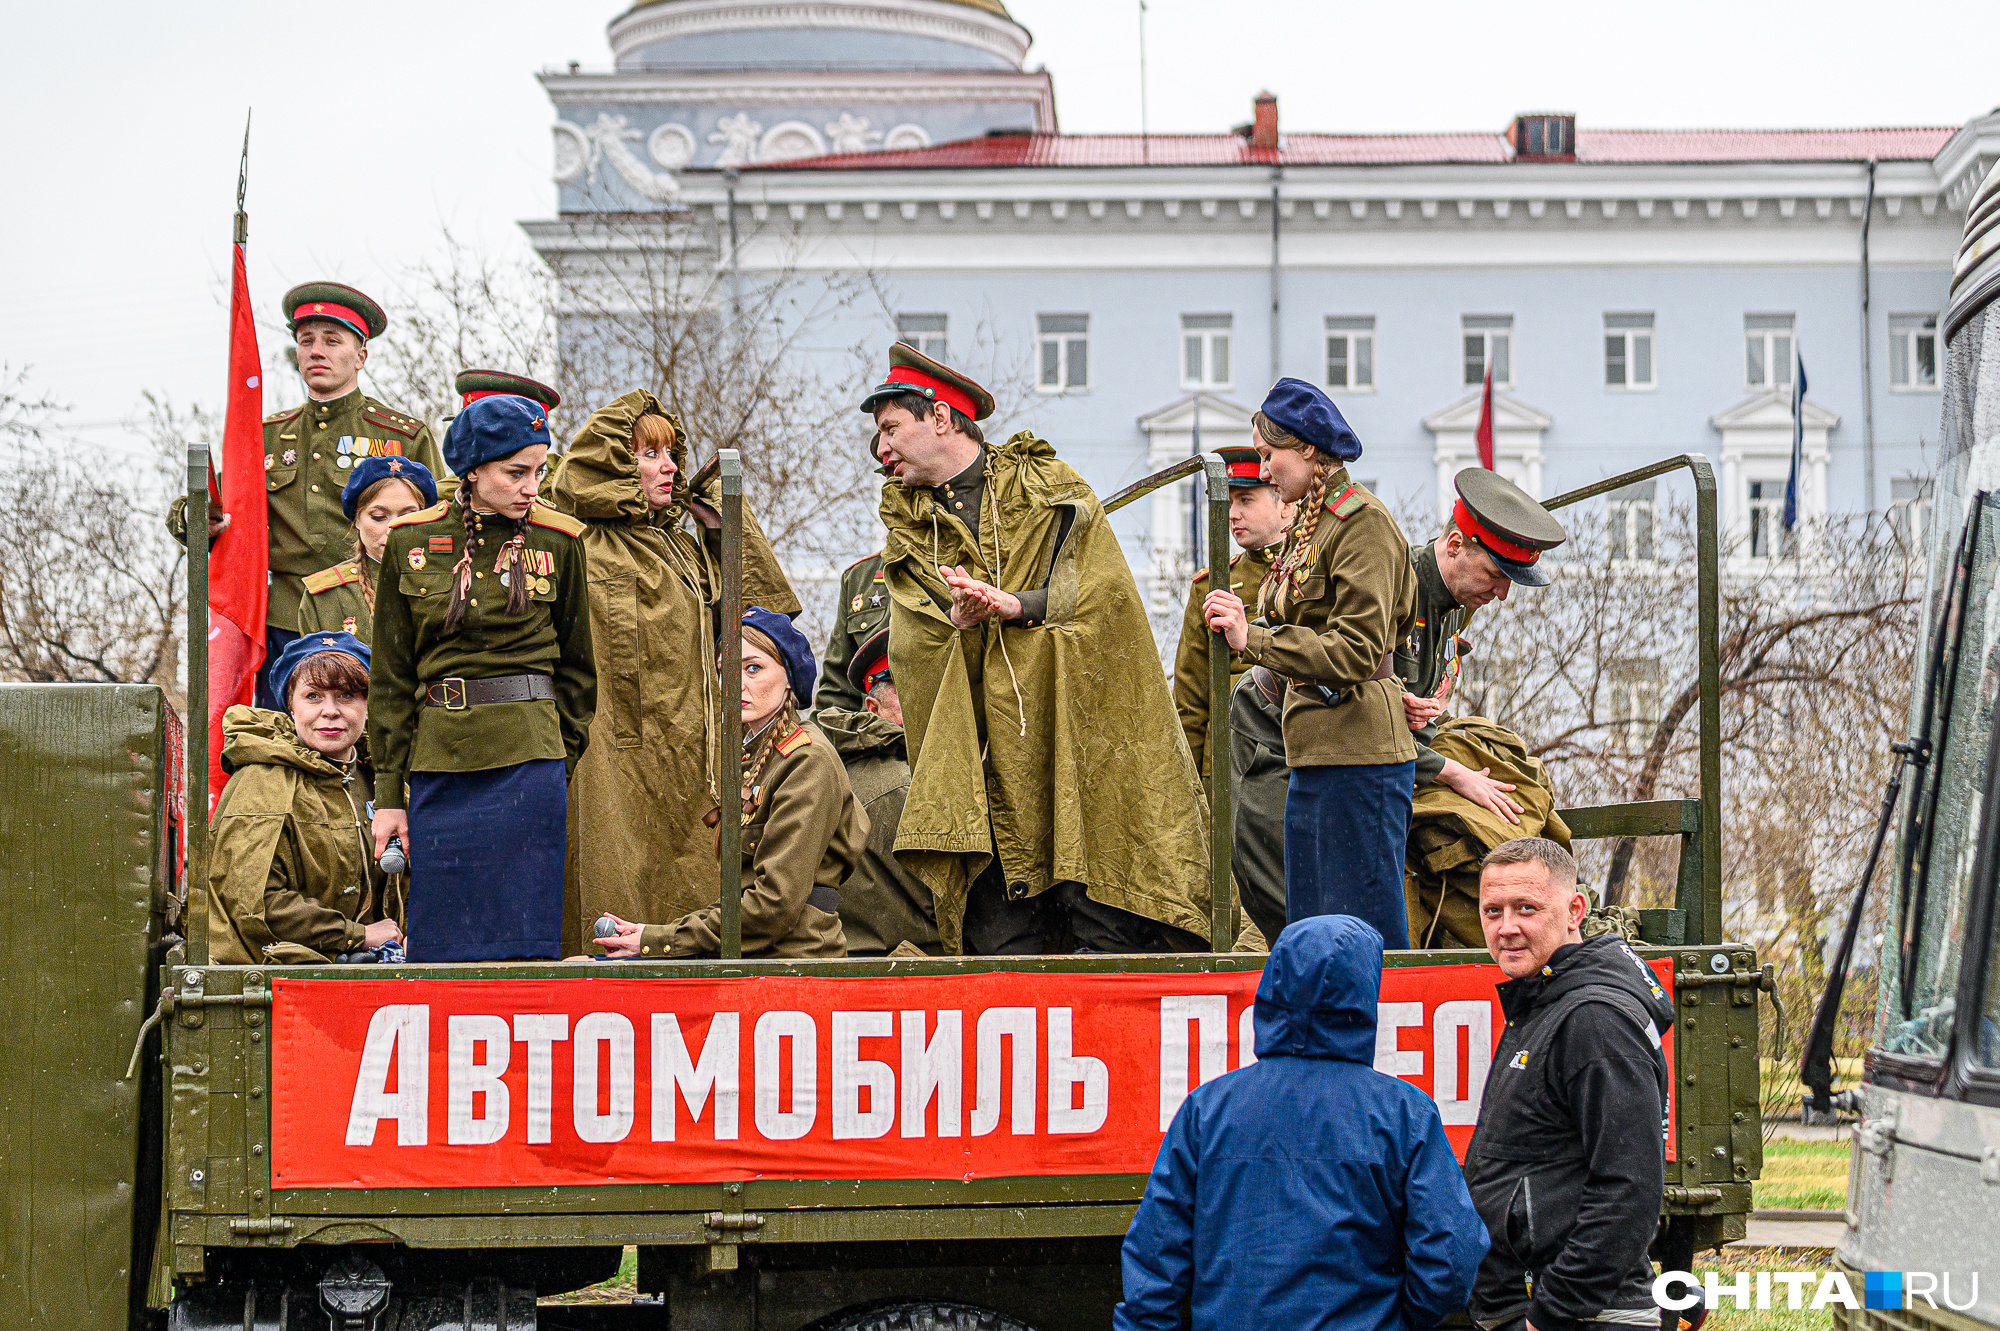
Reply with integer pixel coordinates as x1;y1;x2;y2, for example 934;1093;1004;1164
0;0;2000;446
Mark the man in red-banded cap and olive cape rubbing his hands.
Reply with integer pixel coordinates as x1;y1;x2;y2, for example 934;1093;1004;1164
862;342;1208;953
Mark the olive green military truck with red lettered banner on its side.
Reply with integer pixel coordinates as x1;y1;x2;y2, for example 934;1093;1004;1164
0;448;1770;1331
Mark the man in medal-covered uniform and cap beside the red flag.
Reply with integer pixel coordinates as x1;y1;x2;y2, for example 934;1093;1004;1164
166;282;450;707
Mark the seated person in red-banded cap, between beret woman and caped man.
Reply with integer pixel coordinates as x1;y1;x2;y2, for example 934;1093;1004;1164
812;623;944;957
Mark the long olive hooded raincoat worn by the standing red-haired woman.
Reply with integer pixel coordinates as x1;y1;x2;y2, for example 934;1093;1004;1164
544;390;804;955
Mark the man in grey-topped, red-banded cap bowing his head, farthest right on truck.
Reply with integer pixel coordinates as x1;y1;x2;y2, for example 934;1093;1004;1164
1396;468;1568;823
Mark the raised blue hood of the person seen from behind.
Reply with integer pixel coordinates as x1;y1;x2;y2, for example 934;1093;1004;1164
1256;915;1382;1065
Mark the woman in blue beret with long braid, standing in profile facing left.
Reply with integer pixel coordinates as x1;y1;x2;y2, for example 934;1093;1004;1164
1204;380;1416;947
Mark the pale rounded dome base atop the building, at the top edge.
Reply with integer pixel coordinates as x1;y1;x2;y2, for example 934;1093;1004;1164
610;0;1030;70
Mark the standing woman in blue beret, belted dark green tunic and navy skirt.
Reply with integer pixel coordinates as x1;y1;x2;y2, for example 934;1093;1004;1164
368;394;598;961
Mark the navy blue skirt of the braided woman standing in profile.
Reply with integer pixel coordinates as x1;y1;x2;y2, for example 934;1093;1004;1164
1272;761;1416;949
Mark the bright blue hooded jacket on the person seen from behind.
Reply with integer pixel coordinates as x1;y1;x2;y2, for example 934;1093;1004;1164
1112;915;1486;1331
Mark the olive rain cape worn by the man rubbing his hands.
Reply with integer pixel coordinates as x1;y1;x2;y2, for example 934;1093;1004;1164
880;434;1208;951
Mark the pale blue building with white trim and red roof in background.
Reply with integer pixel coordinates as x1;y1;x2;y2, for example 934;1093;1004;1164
526;0;2000;598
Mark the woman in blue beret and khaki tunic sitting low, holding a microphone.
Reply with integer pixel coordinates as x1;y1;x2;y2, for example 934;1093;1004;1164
598;606;868;959
